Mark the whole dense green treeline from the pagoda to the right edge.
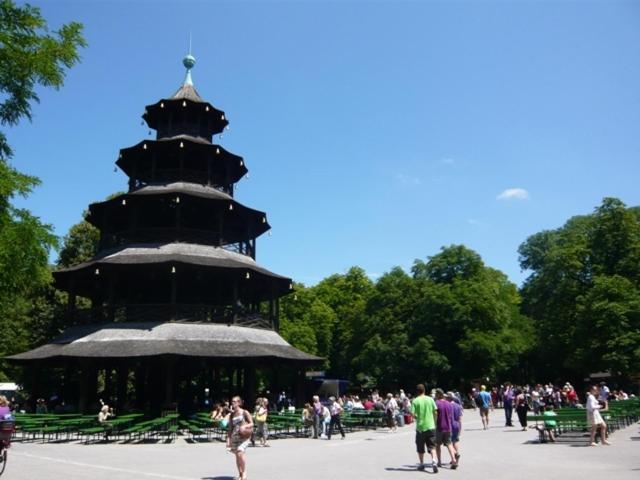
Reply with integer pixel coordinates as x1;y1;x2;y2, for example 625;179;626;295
282;198;640;387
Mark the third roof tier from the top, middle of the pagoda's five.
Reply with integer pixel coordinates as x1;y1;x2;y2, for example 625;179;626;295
86;182;271;245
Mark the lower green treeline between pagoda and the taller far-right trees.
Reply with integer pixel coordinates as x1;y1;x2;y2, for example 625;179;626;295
281;245;534;387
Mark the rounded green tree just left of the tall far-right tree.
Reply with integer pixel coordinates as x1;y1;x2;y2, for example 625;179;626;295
410;245;532;385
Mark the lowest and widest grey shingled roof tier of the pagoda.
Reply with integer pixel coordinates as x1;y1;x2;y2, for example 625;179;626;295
7;322;323;364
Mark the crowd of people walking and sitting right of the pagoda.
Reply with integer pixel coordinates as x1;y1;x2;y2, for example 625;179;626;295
211;382;630;479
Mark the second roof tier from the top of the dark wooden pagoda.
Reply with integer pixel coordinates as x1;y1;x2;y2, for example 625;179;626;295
116;135;248;185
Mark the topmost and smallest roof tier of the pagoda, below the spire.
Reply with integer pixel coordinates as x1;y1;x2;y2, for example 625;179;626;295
142;94;229;139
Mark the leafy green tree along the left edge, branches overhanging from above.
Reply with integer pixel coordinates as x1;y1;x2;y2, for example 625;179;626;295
0;0;85;378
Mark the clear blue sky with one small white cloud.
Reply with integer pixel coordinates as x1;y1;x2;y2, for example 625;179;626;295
8;1;640;284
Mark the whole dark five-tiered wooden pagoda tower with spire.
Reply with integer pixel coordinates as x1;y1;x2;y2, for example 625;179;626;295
9;55;322;411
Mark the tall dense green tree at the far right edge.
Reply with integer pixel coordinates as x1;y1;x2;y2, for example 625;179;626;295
519;198;640;379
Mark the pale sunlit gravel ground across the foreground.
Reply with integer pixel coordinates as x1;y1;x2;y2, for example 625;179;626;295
3;410;640;480
